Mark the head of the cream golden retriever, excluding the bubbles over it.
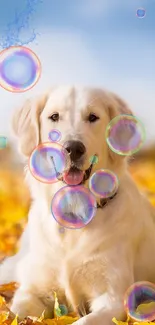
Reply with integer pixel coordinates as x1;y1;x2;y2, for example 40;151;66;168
13;87;132;192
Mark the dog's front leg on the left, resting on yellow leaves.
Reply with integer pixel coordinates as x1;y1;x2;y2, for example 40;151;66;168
11;254;63;319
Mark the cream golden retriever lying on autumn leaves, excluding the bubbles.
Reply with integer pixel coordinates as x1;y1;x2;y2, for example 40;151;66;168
0;86;155;325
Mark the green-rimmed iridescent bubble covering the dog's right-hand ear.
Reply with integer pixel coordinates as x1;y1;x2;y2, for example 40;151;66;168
106;114;145;156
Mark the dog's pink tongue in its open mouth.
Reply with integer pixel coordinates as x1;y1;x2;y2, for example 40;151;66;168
63;170;84;185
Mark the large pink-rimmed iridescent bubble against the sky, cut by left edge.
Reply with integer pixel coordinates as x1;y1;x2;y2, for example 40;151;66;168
0;46;41;93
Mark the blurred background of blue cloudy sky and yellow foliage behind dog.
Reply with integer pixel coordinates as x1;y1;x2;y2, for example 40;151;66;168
0;0;155;259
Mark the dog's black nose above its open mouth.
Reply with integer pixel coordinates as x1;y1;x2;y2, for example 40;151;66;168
64;140;86;161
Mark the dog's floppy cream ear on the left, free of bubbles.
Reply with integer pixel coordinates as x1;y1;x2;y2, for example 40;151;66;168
12;94;48;157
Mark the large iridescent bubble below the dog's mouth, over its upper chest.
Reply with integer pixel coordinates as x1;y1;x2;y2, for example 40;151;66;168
51;185;97;229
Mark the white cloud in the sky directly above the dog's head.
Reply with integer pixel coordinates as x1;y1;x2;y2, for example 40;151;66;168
0;31;155;144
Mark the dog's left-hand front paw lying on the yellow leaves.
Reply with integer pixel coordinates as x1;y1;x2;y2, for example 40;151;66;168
11;289;45;319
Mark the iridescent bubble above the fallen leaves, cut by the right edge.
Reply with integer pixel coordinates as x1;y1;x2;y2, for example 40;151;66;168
124;281;155;322
